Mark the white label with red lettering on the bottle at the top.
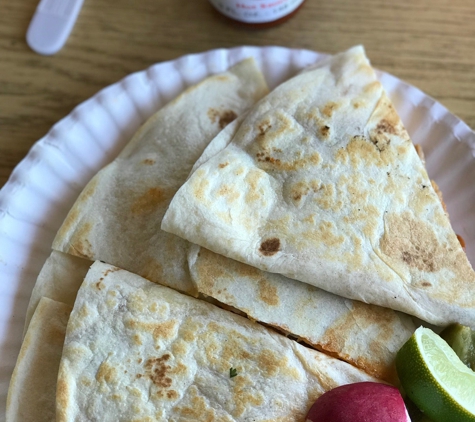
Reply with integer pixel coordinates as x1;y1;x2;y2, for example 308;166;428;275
210;0;304;23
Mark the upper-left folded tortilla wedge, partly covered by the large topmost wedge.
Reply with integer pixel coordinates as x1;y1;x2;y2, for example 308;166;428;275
53;59;268;295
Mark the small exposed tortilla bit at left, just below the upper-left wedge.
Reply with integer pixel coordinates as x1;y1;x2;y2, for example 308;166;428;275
24;251;92;335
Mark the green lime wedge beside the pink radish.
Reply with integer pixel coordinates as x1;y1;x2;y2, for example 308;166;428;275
396;327;475;422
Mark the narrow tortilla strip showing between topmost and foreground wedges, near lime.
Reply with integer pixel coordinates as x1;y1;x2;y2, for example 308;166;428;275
189;245;416;385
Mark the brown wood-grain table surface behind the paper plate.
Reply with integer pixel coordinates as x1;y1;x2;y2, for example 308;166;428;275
0;0;475;187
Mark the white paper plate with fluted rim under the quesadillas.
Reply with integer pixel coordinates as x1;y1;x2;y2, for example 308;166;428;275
0;47;475;420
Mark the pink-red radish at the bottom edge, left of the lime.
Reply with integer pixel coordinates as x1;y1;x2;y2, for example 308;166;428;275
306;382;411;422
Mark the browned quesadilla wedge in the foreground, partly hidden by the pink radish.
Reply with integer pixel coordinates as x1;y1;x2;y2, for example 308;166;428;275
56;262;380;422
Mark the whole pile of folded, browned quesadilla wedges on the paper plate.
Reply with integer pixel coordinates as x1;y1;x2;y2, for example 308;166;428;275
7;47;475;421
